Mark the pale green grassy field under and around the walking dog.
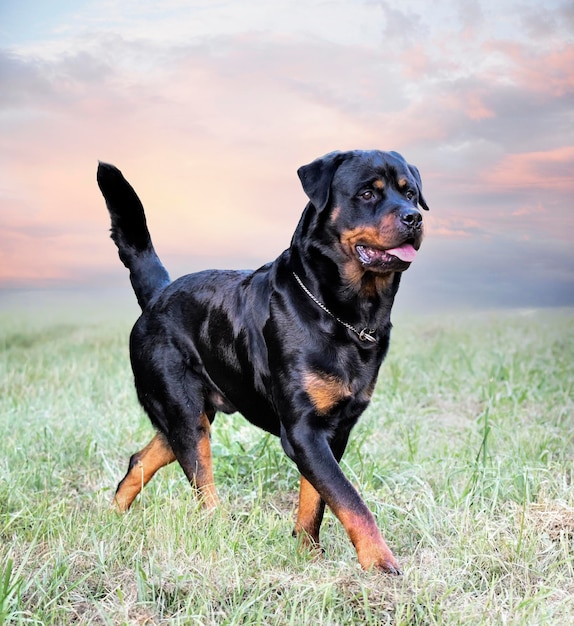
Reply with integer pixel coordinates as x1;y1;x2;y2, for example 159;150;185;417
0;298;574;625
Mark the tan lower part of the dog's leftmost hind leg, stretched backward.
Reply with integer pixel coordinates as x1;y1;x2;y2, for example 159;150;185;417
114;433;175;512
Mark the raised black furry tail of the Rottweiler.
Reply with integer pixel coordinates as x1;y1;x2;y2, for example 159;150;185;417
97;162;170;310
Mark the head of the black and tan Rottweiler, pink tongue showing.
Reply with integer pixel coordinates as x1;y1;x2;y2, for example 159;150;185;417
297;150;428;282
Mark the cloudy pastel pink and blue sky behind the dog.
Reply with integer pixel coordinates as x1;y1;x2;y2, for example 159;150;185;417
0;0;574;310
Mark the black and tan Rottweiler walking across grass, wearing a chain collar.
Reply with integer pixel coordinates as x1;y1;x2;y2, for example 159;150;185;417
98;150;428;573
